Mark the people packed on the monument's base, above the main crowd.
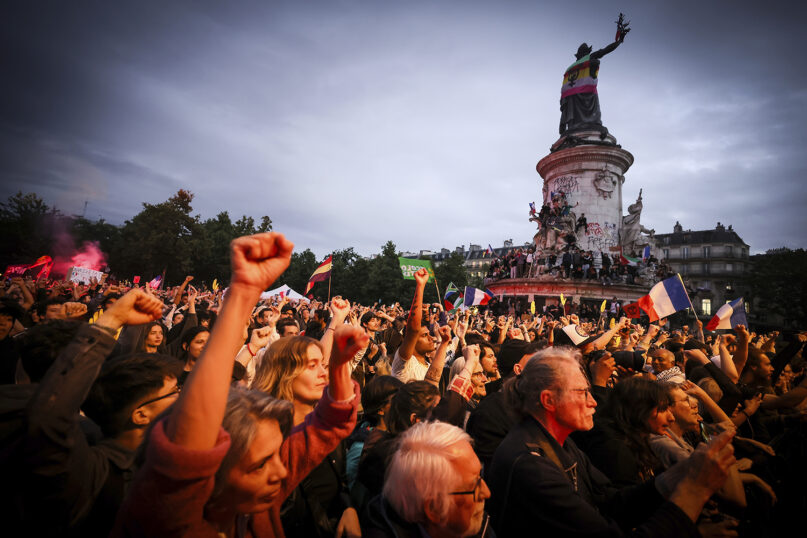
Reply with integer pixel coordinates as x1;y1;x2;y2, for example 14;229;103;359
485;244;675;285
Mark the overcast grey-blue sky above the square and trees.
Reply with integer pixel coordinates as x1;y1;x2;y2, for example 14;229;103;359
0;0;807;256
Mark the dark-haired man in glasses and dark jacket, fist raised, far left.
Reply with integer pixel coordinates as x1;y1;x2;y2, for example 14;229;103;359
7;289;182;536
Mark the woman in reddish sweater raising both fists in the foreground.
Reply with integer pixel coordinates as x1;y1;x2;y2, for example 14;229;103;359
113;232;367;537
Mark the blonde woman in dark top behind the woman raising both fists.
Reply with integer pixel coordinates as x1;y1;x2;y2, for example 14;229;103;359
252;310;361;537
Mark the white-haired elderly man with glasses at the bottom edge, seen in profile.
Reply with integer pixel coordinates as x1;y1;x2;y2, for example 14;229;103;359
363;422;492;538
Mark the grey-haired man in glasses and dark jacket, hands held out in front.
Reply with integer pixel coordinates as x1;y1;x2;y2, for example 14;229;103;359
485;347;735;537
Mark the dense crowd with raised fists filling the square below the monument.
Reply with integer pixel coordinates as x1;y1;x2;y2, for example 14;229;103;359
0;228;807;537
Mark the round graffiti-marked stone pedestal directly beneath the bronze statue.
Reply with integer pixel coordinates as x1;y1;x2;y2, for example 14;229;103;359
536;131;633;253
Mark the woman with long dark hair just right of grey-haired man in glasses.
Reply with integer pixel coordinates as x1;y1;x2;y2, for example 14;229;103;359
575;377;675;486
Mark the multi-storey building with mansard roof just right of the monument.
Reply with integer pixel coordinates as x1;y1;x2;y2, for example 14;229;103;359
655;222;750;316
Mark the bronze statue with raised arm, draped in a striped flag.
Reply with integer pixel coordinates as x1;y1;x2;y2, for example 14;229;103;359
560;13;630;140
